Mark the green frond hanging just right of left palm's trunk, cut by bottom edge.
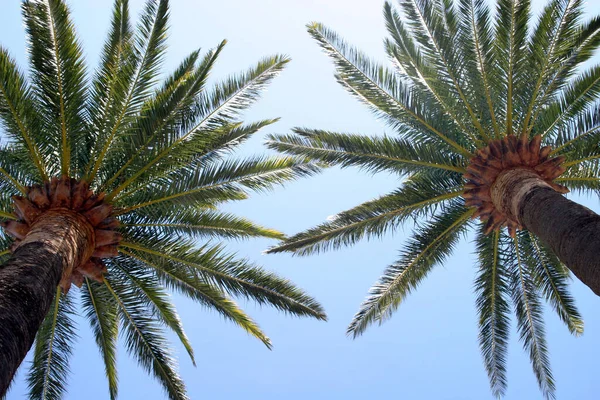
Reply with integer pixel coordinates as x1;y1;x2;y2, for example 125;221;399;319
27;289;77;399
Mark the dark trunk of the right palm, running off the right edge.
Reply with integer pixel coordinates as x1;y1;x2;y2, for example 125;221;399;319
492;169;600;296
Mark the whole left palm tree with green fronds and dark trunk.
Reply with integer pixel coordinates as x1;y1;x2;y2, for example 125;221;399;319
0;0;325;399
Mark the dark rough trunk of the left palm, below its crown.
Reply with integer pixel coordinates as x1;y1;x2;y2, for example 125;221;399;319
0;209;94;398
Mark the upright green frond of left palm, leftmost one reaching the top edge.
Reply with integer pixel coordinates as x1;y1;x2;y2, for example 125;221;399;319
22;0;86;175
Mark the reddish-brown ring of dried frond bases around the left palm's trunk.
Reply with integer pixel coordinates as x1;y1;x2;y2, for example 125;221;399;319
0;177;123;293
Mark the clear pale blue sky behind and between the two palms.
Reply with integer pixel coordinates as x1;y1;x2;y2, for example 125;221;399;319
0;0;600;400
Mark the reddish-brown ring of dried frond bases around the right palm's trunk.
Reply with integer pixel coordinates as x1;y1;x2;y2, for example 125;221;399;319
463;135;569;237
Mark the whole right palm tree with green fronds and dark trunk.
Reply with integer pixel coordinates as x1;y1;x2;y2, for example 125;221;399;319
268;0;600;398
